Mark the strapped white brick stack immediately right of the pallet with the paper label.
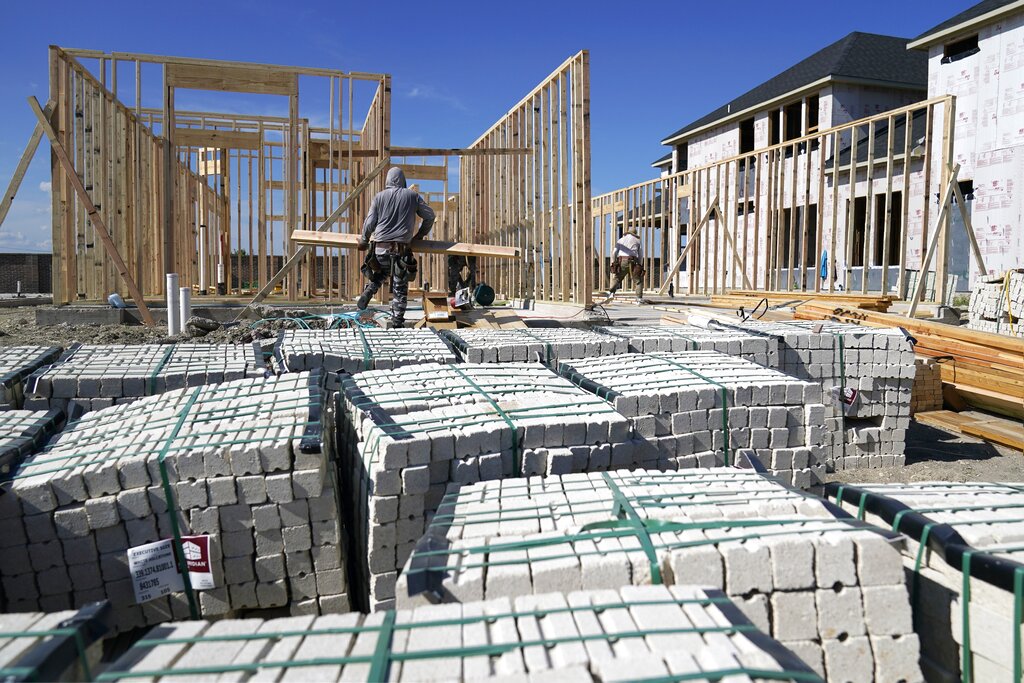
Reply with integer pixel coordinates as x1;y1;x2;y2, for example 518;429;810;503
337;364;636;609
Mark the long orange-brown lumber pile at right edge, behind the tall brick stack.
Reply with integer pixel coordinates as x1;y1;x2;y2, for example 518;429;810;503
795;302;1024;420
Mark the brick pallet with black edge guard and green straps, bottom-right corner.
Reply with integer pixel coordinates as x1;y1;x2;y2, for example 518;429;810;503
825;481;1024;681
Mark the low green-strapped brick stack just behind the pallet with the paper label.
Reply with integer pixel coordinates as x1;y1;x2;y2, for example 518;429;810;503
26;344;266;414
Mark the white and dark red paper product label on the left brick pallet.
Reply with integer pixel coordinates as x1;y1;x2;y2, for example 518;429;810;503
128;536;214;604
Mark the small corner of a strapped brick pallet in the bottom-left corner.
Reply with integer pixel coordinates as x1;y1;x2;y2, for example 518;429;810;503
0;602;111;683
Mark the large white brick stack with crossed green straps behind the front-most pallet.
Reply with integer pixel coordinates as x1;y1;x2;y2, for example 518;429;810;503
397;469;921;681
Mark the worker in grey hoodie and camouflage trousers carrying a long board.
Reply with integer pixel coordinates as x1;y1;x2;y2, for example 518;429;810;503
355;167;434;328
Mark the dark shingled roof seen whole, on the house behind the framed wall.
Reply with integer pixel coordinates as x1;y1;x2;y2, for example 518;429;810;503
662;31;928;144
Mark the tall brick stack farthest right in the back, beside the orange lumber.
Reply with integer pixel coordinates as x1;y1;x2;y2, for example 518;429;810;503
723;321;914;471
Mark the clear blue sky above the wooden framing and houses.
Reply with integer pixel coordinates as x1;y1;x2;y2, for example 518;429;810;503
0;0;973;251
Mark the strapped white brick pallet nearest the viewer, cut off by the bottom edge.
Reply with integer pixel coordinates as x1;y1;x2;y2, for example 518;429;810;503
100;586;820;683
